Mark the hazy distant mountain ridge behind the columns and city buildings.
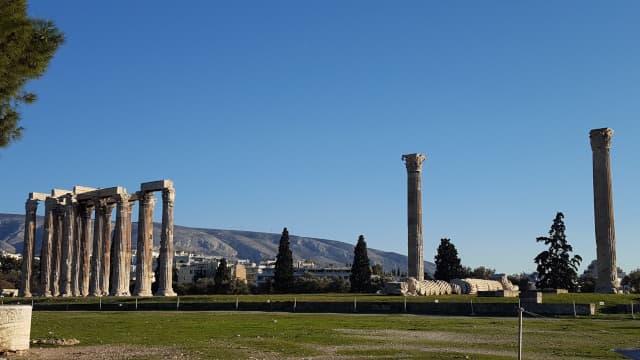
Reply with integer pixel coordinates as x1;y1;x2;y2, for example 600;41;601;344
0;214;435;274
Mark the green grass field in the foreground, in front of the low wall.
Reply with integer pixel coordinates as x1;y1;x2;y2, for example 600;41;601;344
31;311;640;359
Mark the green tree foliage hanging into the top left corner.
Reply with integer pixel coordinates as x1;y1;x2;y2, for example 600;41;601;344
0;0;64;148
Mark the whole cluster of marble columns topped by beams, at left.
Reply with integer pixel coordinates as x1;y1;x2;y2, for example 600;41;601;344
20;180;175;297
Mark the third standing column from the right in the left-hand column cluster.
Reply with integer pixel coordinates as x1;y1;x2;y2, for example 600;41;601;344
109;194;131;296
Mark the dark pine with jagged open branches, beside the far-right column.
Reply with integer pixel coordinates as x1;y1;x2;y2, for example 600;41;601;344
534;212;582;291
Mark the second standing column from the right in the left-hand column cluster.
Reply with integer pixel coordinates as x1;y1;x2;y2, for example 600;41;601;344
133;192;155;296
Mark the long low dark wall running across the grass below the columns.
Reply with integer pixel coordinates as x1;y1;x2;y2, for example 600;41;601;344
28;300;595;316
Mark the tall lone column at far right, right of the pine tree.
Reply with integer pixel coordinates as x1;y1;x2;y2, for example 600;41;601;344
589;128;619;293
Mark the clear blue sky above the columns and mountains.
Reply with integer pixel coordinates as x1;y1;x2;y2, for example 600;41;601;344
0;0;640;273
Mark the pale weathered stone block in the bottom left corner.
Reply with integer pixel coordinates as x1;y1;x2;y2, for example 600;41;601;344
0;305;31;352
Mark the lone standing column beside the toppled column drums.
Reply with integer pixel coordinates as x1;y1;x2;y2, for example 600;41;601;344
402;154;426;280
